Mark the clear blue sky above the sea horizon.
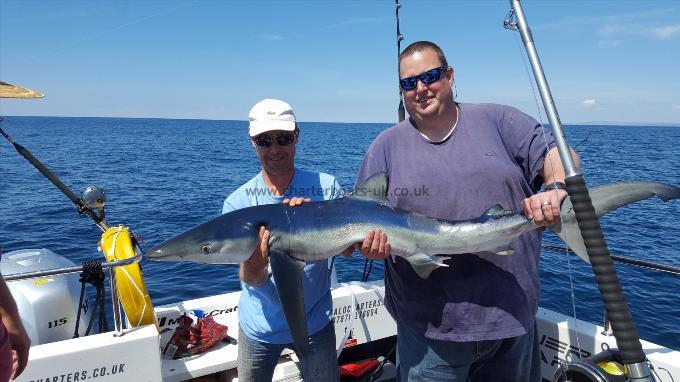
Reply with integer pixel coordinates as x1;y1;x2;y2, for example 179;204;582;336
0;0;680;125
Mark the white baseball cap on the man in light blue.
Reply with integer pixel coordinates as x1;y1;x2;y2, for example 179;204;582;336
248;98;295;137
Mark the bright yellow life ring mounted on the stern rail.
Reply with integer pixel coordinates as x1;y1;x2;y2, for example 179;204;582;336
99;225;158;328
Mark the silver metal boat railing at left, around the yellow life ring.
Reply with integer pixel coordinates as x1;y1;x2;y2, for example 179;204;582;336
3;253;142;336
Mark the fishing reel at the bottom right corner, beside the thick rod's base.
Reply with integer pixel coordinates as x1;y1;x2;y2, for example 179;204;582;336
553;349;644;382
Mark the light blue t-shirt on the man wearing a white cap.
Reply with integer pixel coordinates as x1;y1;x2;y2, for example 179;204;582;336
222;168;343;344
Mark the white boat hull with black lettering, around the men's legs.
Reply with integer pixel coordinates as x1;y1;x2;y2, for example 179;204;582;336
11;281;680;382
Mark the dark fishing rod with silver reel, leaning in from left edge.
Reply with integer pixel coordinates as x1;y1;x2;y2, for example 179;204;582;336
0;118;108;231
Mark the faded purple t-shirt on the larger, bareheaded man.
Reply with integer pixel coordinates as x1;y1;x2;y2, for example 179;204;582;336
357;104;555;341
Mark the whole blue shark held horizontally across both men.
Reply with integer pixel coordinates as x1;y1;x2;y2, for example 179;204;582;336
146;173;680;355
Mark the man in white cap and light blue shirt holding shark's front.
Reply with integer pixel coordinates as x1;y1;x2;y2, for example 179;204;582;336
222;99;342;382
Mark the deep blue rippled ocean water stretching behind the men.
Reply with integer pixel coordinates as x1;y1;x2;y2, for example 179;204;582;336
0;117;680;349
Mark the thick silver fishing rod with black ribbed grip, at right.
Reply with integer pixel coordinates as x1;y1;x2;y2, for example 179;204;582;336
504;0;654;382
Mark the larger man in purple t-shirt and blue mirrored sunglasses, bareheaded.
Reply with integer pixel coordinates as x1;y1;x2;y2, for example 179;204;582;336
357;41;580;382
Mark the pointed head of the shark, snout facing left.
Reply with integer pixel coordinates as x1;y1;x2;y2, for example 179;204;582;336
145;211;259;264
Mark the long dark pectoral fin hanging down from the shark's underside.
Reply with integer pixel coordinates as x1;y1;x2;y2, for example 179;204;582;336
269;252;309;357
